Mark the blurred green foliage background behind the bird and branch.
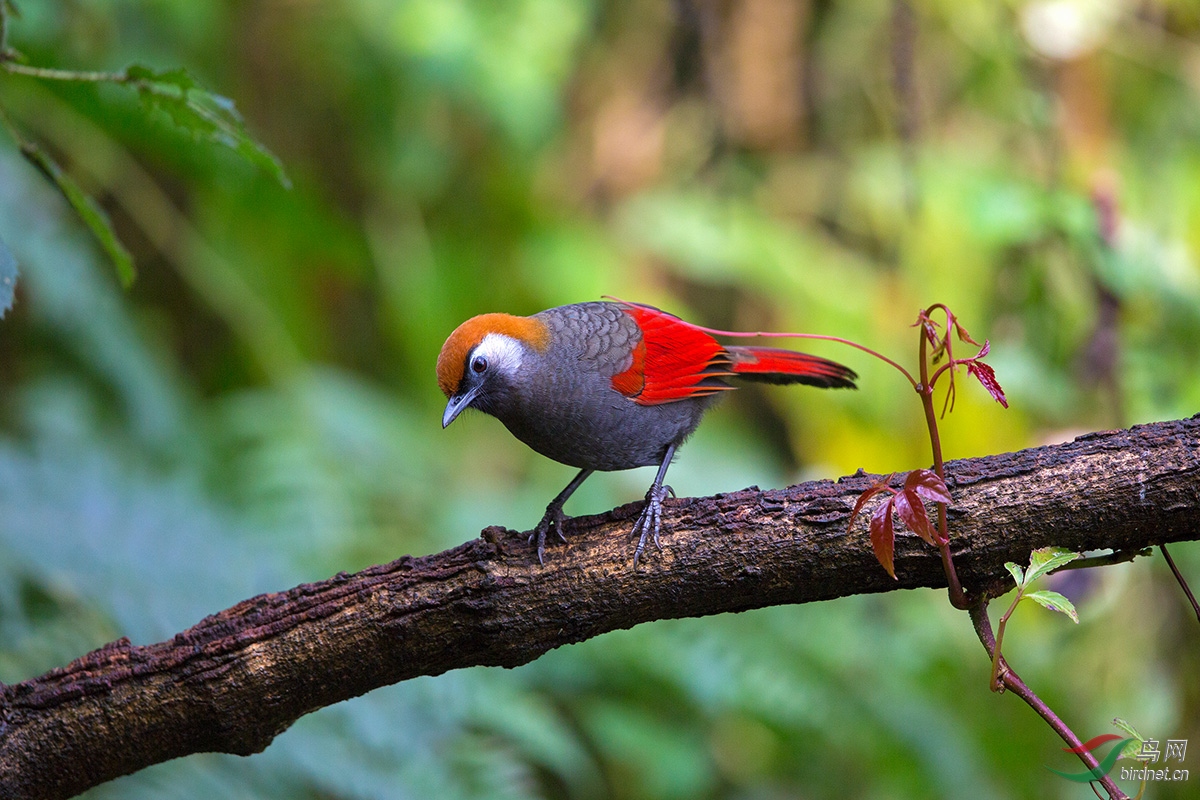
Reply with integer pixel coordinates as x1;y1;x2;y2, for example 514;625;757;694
0;0;1200;800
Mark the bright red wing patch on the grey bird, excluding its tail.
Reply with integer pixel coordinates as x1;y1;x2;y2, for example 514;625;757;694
612;303;733;405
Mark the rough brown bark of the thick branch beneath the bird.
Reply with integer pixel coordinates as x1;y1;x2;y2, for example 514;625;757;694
7;416;1200;799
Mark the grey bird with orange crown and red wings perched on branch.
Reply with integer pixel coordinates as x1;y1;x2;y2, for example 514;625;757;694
437;300;858;570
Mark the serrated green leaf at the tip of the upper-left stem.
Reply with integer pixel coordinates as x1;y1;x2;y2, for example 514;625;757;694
125;64;292;188
